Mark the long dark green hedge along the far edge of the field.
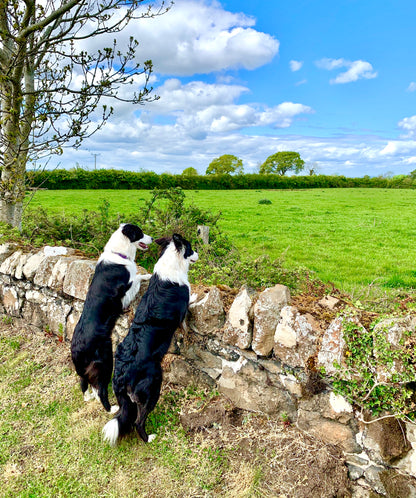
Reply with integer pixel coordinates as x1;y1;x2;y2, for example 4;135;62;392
27;169;416;190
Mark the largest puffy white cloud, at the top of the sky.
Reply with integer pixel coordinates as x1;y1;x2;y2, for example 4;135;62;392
78;0;279;76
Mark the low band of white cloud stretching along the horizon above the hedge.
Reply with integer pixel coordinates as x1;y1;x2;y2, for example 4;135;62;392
49;124;416;176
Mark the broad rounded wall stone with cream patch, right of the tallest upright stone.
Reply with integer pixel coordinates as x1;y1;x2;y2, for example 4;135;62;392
274;306;320;368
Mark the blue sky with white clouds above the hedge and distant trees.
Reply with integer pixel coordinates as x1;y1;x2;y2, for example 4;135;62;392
48;0;416;177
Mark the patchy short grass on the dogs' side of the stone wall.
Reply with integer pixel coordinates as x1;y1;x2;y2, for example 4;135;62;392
0;324;346;498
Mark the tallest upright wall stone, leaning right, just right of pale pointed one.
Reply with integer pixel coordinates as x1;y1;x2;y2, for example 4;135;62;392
251;284;290;356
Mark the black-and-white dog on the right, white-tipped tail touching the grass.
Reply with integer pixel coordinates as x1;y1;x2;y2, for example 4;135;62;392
103;234;198;446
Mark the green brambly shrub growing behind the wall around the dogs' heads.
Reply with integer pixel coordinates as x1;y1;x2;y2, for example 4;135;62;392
20;188;306;289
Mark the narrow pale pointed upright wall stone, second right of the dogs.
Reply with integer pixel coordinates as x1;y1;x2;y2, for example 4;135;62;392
223;288;253;349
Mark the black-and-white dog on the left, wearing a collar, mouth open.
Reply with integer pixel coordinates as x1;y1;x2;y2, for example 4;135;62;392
71;223;153;411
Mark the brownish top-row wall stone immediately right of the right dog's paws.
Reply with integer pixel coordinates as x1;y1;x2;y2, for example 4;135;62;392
188;287;225;335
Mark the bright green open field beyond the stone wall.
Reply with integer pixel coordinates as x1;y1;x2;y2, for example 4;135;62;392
25;189;416;291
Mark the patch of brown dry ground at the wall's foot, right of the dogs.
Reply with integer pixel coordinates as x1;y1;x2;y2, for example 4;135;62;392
180;397;351;498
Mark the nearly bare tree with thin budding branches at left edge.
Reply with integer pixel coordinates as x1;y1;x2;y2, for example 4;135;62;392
0;0;167;227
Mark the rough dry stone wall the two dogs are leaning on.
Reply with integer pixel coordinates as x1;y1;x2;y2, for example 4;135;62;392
0;244;416;498
